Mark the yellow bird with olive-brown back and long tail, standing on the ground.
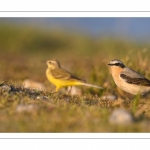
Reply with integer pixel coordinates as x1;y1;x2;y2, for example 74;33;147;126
46;60;103;92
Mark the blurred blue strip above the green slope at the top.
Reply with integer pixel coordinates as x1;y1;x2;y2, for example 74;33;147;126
0;17;150;41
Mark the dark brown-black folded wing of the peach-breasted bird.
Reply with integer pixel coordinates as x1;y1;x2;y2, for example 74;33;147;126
120;74;150;86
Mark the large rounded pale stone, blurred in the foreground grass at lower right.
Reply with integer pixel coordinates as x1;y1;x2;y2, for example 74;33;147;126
109;109;133;125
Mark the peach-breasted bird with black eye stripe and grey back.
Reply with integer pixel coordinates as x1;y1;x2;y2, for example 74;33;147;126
108;59;150;95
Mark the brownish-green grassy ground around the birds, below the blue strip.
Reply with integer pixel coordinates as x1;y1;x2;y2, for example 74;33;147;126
0;22;150;132
